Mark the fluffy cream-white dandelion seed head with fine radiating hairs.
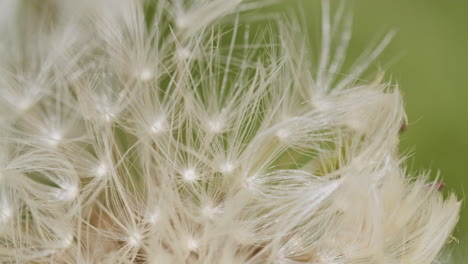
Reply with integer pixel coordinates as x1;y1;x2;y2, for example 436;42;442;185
0;0;460;264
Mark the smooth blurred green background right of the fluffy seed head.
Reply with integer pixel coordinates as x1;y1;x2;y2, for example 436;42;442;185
302;0;468;256
